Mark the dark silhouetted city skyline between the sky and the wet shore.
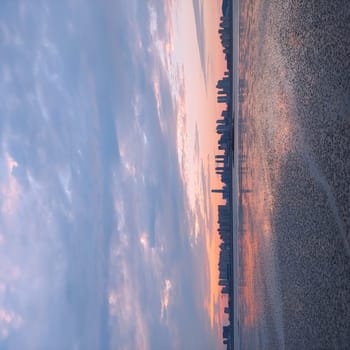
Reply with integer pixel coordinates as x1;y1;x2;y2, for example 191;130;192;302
212;0;235;349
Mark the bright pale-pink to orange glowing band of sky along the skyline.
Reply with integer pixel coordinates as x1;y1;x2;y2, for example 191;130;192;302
172;0;226;340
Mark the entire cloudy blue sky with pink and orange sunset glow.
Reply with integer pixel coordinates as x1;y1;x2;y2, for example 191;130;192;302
0;0;225;350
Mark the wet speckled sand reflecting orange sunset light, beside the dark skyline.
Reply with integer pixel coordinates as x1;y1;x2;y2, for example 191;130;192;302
239;0;350;349
